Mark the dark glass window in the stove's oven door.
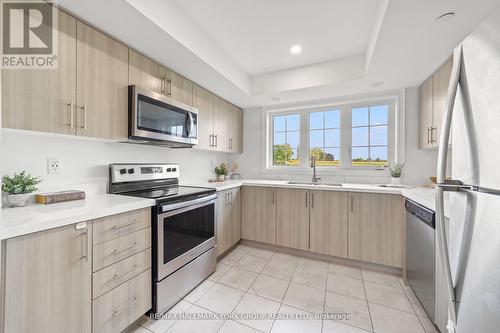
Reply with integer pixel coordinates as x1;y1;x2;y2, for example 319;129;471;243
163;204;215;264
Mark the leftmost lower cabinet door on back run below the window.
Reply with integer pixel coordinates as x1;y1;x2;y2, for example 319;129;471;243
241;186;276;244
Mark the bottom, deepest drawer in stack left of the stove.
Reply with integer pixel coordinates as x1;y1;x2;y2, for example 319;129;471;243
92;269;151;333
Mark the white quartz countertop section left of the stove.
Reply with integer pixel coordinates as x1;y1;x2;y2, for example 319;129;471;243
0;194;155;240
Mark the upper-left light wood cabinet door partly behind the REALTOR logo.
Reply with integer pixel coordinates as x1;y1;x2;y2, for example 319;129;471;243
2;11;76;134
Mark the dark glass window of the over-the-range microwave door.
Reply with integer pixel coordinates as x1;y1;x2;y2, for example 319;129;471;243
137;95;189;137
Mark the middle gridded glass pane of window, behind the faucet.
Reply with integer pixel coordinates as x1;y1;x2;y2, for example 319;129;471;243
309;110;340;167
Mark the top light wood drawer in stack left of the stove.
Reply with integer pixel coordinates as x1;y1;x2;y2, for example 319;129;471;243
92;208;151;245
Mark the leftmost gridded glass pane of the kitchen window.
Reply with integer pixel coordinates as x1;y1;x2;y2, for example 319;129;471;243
273;114;300;166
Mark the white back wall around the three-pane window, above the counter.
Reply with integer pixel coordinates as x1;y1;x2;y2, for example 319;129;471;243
237;88;437;185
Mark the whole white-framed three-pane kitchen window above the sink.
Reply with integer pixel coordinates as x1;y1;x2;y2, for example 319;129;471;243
265;96;399;172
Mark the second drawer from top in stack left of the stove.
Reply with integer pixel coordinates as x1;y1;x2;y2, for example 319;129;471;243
92;228;151;272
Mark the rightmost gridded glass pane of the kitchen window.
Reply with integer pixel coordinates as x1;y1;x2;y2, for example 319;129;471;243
351;105;389;166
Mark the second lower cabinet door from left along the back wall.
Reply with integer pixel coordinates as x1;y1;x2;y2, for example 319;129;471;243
276;188;309;250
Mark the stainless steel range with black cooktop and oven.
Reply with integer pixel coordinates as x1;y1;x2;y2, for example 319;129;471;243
109;164;217;314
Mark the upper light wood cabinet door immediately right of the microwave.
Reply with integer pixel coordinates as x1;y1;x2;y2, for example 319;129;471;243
193;84;215;149
